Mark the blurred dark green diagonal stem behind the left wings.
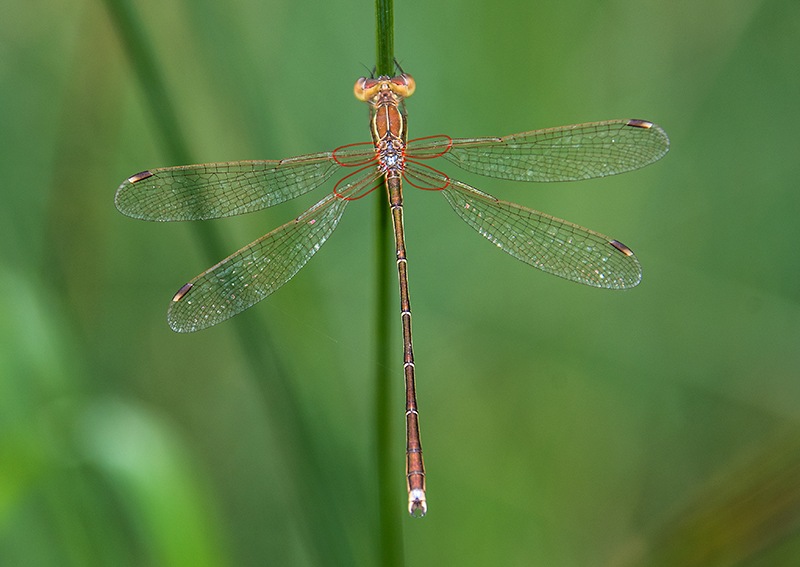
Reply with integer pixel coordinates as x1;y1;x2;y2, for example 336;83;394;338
105;0;356;565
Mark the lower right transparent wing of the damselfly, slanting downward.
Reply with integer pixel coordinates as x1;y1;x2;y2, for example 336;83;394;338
442;179;642;289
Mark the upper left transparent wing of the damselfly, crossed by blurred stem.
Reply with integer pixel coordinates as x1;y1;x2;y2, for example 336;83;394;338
114;152;341;221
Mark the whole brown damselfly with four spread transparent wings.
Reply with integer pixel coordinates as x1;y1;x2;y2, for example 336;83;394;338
115;74;669;515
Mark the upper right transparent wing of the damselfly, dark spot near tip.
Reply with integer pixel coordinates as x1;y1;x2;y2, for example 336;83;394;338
408;120;669;181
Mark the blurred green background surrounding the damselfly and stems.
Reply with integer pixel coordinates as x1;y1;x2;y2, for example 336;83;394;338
0;0;800;566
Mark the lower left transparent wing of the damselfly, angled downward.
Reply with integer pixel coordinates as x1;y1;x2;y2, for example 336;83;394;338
167;194;349;333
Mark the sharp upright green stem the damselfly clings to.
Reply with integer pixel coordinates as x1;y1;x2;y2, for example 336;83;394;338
375;0;405;566
